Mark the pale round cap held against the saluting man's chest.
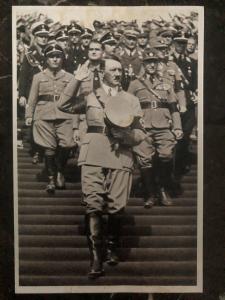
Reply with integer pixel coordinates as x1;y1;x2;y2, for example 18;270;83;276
105;96;134;128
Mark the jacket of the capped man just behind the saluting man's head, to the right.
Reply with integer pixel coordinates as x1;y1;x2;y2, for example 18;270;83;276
119;48;143;75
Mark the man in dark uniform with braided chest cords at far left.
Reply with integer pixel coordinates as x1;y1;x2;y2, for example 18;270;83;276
18;22;49;164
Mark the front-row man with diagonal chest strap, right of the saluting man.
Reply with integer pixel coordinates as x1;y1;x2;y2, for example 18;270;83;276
128;51;182;208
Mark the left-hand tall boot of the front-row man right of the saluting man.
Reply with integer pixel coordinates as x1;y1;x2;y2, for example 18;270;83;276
141;168;156;208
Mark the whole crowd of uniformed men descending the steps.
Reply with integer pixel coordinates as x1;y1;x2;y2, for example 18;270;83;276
17;13;198;278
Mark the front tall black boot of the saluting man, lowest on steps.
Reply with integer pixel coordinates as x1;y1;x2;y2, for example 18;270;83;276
85;212;104;279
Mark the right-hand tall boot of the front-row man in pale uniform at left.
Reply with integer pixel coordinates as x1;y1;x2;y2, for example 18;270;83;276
56;147;70;190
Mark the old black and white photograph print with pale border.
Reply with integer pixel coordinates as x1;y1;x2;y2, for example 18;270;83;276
12;5;204;294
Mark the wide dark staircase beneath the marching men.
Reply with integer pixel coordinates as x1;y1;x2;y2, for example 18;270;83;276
18;126;197;286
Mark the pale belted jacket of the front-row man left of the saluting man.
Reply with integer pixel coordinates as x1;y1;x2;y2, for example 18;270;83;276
26;69;73;120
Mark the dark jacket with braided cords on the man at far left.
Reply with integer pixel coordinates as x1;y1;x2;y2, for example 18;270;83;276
19;45;45;98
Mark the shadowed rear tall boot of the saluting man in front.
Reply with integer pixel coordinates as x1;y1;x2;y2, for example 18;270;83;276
106;211;123;266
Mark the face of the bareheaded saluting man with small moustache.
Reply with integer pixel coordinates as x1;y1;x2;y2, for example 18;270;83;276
104;59;122;87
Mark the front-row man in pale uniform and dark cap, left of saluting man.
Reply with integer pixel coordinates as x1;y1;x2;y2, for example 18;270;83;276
26;43;74;193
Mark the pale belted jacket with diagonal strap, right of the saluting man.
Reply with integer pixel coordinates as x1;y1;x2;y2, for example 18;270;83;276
128;76;182;129
